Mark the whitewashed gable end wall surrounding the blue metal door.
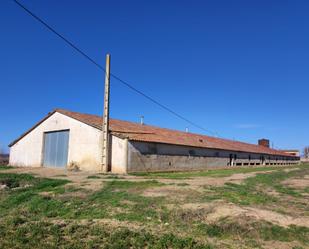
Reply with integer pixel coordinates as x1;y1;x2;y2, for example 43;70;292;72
10;112;101;171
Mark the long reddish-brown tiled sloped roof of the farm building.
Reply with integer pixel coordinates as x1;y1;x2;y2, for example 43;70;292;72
9;109;290;156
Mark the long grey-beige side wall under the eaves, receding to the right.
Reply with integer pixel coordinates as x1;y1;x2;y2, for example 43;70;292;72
127;141;299;172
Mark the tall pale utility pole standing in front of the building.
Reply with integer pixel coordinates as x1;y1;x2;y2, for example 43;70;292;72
102;54;111;172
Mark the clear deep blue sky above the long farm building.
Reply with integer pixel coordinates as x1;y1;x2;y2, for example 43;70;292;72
0;0;309;154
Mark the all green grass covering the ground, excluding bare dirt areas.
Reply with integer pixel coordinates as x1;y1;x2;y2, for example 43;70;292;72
0;166;309;249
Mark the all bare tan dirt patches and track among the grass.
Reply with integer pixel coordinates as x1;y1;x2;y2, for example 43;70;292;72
5;167;309;249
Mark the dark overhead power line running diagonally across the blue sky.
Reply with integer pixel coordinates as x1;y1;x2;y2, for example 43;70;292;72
13;0;218;136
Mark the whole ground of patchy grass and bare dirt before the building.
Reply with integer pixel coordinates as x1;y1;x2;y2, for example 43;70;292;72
0;165;309;249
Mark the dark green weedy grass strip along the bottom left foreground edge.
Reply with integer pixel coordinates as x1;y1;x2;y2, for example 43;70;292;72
0;217;213;249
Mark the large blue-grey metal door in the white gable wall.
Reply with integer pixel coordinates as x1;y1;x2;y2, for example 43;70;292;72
43;131;69;168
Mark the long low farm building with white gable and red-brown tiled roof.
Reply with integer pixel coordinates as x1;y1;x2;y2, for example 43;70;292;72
9;109;300;173
